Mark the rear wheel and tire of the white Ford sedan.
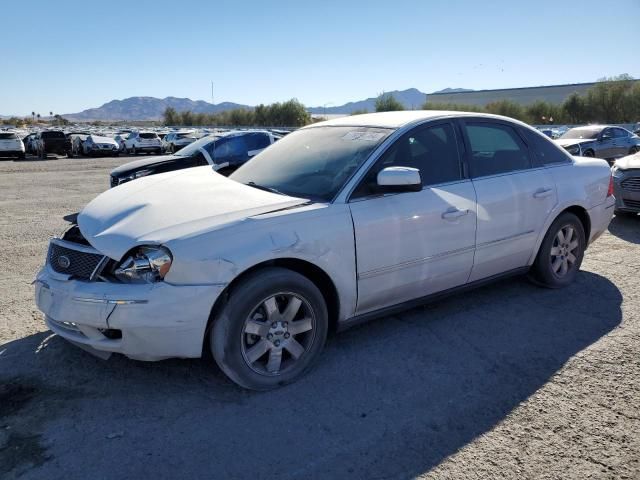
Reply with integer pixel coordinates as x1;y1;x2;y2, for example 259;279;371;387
530;212;587;288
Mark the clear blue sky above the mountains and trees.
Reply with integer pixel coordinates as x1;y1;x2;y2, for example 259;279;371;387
0;0;640;114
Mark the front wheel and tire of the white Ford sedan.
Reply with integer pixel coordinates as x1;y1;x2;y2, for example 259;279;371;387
209;268;328;390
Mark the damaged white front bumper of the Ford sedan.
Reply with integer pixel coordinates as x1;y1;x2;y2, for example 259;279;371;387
34;265;224;361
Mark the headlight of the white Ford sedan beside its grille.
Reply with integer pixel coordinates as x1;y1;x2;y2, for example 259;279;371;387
113;246;173;283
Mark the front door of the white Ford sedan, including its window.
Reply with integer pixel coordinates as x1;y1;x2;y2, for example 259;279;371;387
350;122;476;314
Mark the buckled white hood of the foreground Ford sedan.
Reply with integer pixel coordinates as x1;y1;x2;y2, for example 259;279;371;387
78;166;308;260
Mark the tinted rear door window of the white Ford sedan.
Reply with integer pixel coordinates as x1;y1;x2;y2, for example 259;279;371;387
465;122;531;178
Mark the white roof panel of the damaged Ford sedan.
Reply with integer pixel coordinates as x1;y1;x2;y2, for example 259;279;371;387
304;110;521;128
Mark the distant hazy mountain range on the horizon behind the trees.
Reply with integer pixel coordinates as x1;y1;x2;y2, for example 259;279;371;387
41;88;472;122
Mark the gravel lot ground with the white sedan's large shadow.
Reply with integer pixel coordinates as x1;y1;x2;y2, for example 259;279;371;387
0;159;640;480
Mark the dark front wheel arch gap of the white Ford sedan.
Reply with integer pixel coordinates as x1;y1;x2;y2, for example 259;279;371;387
203;257;340;349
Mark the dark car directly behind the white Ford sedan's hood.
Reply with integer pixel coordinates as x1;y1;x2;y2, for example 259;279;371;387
110;130;276;187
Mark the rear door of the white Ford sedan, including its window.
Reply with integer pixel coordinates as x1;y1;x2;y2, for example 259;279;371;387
461;118;557;281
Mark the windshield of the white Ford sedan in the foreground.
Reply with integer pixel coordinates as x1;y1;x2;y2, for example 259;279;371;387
229;127;393;201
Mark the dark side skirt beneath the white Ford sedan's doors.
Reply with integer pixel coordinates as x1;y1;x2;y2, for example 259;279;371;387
338;267;530;332
